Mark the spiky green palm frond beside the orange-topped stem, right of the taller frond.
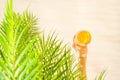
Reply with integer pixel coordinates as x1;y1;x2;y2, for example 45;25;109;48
36;33;79;80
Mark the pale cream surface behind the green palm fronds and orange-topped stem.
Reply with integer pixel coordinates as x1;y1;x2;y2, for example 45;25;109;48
0;0;120;80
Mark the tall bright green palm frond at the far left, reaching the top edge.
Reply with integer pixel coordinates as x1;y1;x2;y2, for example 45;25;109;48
0;0;39;80
